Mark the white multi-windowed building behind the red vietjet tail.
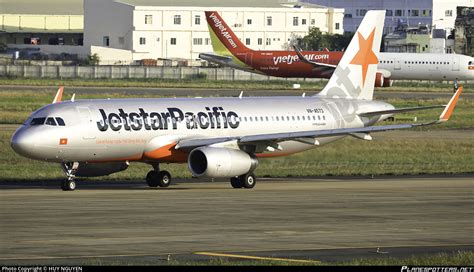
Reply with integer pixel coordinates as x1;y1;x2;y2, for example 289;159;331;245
84;0;344;64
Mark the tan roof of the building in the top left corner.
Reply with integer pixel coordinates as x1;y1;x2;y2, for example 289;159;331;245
0;0;84;15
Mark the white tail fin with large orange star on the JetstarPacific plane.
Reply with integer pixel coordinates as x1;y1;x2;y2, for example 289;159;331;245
318;10;385;100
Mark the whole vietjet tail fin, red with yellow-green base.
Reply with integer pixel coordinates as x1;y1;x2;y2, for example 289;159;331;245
205;11;252;56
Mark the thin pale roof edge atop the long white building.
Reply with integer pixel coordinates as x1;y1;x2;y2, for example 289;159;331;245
118;0;322;8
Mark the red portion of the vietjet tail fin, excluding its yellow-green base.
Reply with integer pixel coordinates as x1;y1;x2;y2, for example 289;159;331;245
205;11;251;54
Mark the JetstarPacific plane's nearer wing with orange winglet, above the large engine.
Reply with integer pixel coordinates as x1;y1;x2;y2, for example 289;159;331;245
175;87;462;149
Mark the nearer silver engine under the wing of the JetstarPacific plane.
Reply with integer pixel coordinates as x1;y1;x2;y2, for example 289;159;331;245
188;147;258;178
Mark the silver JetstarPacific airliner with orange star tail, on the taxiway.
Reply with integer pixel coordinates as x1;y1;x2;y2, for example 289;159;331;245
11;11;462;190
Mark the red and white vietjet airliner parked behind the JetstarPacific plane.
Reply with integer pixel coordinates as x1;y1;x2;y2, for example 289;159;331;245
199;11;474;87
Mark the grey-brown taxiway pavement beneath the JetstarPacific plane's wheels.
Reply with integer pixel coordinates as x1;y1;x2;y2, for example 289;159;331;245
0;176;474;264
